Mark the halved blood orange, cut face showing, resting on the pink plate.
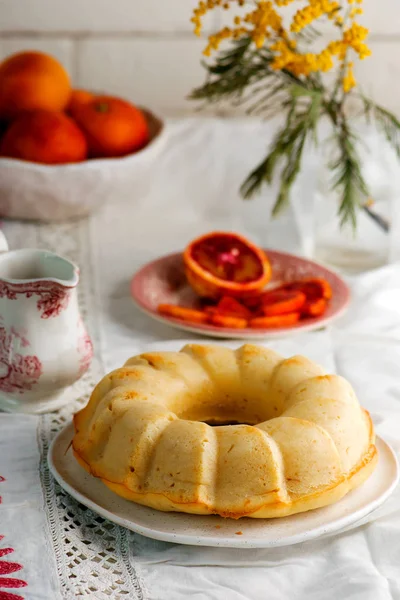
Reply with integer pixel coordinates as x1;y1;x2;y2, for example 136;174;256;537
183;231;271;299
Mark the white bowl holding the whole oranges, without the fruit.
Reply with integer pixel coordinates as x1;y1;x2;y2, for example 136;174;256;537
0;109;165;221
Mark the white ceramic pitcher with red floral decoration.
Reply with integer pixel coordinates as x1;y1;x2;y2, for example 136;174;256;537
0;231;93;413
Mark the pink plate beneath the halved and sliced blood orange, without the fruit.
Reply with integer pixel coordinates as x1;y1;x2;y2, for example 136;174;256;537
131;250;350;339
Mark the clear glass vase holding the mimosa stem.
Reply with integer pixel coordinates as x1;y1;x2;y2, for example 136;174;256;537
291;136;400;274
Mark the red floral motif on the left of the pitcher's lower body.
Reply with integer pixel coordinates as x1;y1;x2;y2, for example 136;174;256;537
0;327;42;394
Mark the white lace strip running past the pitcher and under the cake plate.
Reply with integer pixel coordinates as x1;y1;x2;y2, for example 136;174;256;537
7;221;145;600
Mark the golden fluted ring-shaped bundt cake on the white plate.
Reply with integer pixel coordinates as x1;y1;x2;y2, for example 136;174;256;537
73;344;377;518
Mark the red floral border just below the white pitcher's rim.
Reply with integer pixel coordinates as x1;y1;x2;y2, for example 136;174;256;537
0;281;71;319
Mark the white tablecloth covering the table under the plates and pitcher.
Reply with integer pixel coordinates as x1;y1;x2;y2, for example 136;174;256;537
0;120;400;600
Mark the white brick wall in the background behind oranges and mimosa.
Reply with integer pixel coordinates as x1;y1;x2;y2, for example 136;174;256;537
0;0;400;116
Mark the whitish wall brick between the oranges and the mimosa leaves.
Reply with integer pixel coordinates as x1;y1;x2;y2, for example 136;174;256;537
76;37;208;113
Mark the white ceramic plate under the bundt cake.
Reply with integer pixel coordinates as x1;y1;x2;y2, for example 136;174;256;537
48;423;398;548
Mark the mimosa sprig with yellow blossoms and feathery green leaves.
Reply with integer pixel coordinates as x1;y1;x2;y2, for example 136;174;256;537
191;0;400;227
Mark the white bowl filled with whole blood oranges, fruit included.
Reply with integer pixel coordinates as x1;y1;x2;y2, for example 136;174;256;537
0;51;164;221
